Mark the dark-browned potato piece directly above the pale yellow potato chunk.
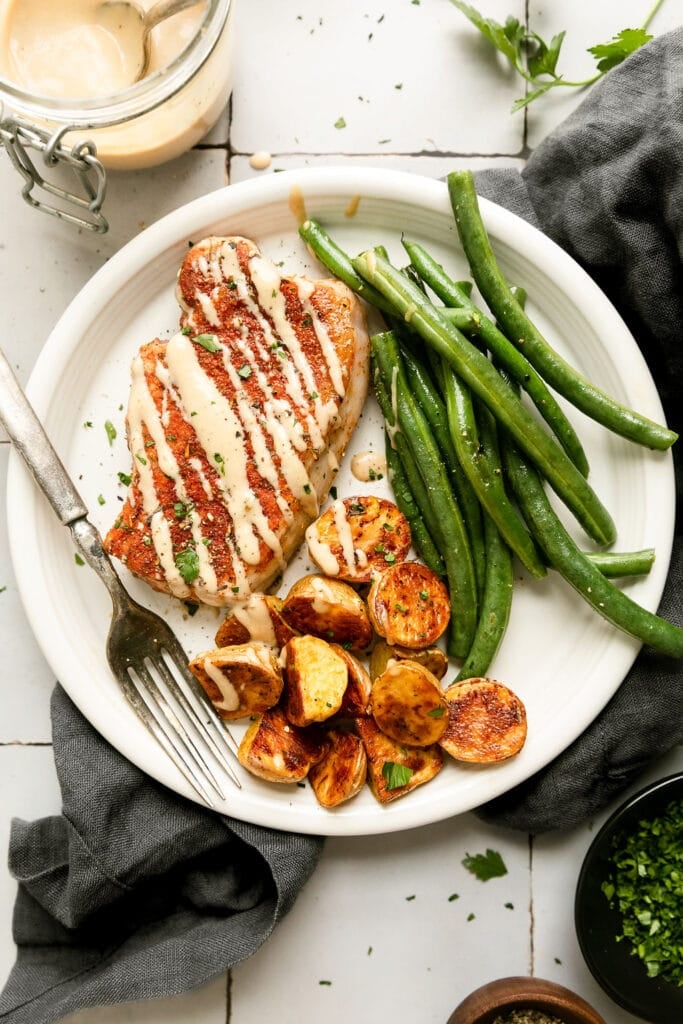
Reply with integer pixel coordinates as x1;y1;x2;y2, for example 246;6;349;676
282;573;373;651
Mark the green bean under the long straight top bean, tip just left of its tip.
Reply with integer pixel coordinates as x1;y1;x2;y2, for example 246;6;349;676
442;366;546;579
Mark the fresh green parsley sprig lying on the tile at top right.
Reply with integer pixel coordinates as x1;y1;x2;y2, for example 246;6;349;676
451;0;664;114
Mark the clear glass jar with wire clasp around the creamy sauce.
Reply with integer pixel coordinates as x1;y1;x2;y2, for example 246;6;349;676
0;0;233;229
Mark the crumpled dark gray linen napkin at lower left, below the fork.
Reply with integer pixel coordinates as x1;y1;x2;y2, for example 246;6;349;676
0;686;322;1024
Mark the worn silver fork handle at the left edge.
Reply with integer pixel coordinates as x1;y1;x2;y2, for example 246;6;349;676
0;350;88;526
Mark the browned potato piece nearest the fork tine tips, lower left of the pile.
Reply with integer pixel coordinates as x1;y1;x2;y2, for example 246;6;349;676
238;708;326;783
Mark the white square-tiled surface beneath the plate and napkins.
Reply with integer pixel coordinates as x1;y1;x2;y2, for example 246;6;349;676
0;0;683;1024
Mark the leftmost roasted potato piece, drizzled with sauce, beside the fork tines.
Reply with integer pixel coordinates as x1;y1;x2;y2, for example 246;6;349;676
189;641;283;721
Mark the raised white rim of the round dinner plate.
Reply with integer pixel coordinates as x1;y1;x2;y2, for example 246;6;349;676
6;166;675;836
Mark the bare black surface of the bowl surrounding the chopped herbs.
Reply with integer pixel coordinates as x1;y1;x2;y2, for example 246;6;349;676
574;772;683;1024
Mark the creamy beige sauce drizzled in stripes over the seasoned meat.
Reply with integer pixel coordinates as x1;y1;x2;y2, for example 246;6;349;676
122;243;352;602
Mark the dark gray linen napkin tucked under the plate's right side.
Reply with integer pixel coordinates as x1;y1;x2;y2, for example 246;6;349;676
476;28;683;833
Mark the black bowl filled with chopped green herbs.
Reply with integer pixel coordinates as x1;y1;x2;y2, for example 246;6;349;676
574;773;683;1024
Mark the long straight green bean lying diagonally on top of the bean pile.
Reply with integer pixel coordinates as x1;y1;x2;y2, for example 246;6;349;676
352;252;616;544
